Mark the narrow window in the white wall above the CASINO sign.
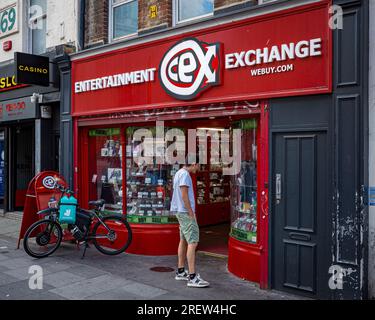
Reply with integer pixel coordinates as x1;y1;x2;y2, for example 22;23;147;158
29;0;47;54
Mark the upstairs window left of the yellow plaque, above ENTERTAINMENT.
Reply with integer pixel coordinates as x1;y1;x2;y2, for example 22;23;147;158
110;0;138;40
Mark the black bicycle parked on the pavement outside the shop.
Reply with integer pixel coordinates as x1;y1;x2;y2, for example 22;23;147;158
23;184;132;259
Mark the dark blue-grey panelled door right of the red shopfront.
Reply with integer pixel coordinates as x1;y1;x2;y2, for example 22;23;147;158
271;131;330;298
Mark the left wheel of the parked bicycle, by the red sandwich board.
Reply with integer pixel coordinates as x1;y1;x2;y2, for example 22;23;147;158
23;219;63;258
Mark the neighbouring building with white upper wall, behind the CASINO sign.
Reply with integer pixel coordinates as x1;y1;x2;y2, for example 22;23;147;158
0;0;82;211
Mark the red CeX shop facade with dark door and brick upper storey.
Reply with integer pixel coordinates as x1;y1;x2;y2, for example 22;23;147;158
54;0;373;299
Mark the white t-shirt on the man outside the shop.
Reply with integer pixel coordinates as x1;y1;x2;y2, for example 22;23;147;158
171;168;195;213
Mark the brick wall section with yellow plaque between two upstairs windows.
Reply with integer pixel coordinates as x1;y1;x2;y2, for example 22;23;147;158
138;0;172;33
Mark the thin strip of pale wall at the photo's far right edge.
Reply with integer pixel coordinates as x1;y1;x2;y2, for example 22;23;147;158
368;0;375;298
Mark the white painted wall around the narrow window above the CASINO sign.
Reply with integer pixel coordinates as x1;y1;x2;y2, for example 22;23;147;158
0;0;79;64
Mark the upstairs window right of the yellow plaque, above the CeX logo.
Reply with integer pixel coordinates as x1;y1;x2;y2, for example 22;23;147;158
174;0;214;23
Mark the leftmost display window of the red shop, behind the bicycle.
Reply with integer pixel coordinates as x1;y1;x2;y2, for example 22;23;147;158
89;128;123;214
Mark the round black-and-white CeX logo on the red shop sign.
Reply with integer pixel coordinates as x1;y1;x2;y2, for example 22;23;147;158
159;38;221;100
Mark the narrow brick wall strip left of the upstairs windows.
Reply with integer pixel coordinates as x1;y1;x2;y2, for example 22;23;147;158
85;0;109;47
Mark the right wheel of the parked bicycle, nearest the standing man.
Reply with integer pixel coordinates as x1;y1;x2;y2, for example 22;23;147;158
92;216;132;255
